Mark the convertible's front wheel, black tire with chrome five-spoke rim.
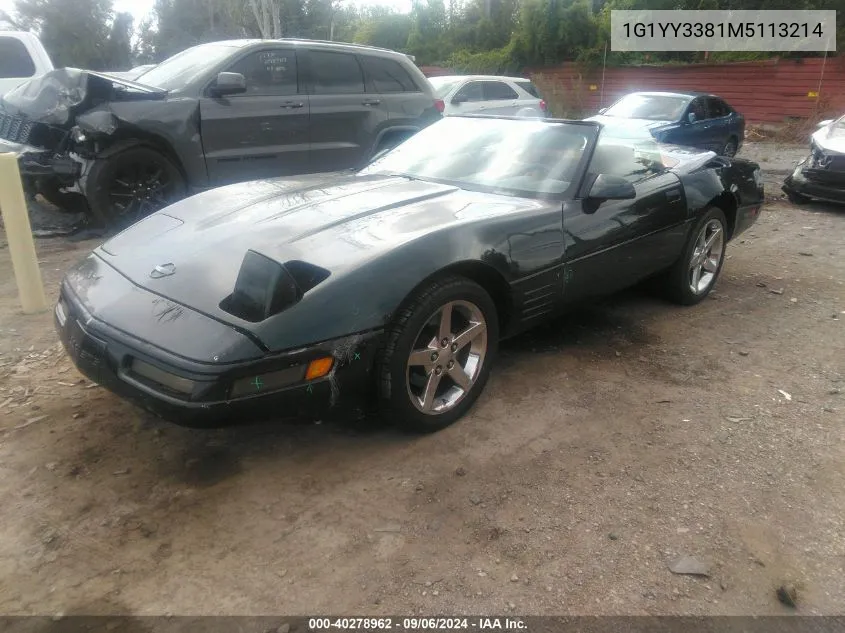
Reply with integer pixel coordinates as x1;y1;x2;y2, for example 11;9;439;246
377;276;499;433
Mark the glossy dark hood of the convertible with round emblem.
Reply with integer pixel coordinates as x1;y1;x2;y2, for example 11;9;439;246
95;174;534;322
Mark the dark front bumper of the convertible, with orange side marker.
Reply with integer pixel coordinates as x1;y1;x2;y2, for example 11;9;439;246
54;283;383;427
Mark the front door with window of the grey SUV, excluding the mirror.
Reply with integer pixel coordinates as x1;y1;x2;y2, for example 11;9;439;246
200;46;309;186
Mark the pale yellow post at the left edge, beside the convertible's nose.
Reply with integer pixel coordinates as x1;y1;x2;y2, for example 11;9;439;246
0;153;48;314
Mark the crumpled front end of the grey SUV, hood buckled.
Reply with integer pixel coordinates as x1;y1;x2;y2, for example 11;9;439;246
0;68;167;207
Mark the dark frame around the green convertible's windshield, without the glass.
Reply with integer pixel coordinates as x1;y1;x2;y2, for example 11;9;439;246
356;114;604;202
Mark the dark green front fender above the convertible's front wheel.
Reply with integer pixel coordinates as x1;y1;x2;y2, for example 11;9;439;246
254;209;563;351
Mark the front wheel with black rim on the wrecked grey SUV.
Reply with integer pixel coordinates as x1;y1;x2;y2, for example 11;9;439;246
88;144;187;230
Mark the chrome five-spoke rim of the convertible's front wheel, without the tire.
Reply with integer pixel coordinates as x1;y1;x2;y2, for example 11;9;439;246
406;301;487;415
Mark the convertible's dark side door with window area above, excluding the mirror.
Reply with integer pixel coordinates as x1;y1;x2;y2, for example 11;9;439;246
563;132;687;302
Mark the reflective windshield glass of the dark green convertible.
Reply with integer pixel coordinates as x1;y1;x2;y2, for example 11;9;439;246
361;117;597;195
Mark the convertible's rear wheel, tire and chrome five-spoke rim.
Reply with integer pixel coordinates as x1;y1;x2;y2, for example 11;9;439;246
666;207;728;305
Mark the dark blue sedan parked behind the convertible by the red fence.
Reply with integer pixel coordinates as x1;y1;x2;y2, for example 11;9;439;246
587;92;745;156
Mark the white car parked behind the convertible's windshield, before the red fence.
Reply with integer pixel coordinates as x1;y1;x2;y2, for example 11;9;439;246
429;75;546;117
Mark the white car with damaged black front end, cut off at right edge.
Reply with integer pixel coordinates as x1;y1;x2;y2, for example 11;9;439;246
783;117;845;203
